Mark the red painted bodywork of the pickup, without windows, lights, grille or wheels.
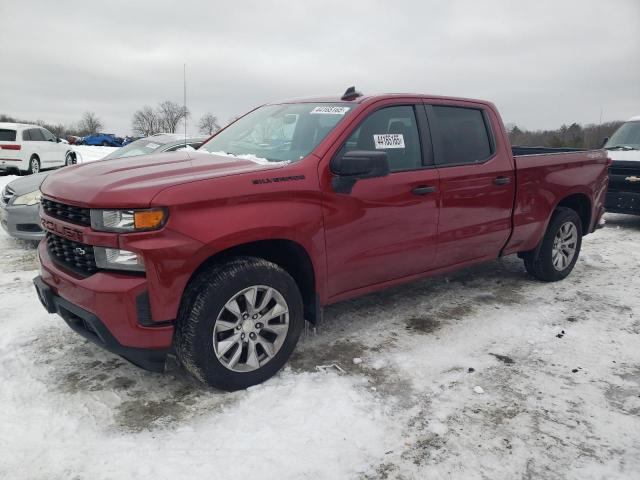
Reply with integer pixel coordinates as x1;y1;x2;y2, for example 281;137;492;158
39;95;607;348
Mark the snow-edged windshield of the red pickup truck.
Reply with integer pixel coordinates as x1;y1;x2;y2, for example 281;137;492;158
199;103;353;162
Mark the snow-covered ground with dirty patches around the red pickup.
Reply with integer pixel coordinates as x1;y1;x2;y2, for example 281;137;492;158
0;204;640;480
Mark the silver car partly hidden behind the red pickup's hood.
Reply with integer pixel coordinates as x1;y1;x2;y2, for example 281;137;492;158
0;134;209;242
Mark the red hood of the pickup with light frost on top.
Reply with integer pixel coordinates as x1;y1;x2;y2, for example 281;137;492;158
41;151;284;208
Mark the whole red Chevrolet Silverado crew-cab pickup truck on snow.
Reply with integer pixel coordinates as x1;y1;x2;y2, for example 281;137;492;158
34;88;609;390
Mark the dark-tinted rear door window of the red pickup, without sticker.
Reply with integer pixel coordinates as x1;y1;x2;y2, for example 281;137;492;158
427;105;494;166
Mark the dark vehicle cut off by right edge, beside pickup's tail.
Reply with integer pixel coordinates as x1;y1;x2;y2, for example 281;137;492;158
604;115;640;215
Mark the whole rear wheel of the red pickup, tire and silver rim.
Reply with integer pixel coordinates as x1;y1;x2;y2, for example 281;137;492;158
523;207;582;282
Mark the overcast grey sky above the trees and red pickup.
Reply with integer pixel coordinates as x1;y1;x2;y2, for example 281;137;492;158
0;0;640;134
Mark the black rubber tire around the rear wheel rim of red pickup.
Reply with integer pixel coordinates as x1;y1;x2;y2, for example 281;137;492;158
523;207;582;282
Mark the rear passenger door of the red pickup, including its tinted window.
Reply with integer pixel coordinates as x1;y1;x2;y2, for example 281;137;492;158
425;101;515;267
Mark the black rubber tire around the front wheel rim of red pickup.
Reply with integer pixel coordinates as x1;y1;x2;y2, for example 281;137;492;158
174;257;304;391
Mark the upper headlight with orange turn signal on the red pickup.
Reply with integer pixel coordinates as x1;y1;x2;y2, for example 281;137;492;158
91;208;168;233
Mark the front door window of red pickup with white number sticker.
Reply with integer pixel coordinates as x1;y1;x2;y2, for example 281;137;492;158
342;105;422;172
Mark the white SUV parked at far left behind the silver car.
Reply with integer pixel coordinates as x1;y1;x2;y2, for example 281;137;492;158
0;122;76;173
